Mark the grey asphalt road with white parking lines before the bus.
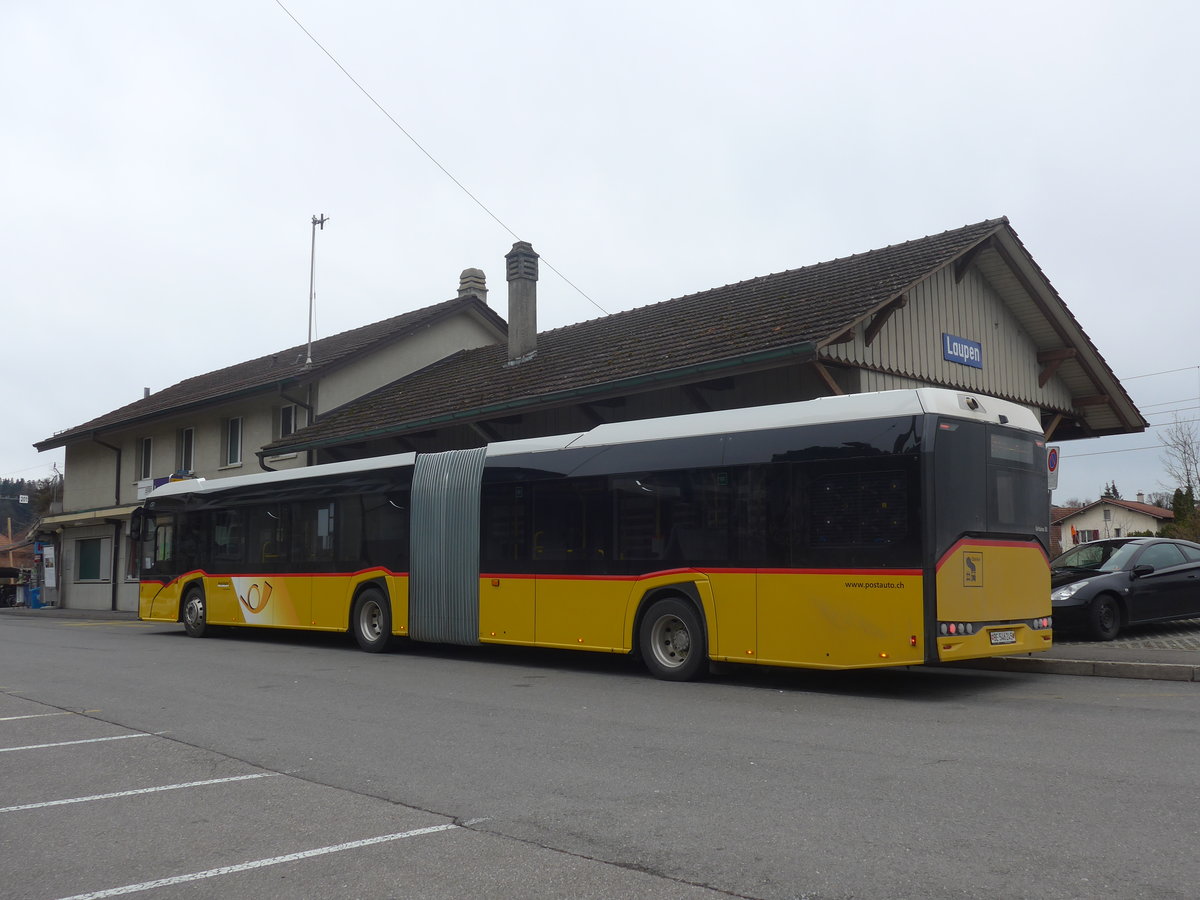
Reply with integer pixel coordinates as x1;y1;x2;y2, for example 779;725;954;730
0;617;1200;900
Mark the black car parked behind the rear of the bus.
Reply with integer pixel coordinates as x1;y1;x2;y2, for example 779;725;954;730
1050;538;1200;641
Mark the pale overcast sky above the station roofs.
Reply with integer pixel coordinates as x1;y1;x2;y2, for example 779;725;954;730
0;0;1200;502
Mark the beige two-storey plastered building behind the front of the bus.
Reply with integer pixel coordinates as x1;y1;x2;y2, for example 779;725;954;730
35;283;506;610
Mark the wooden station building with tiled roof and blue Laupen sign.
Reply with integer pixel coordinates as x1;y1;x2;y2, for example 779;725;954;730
265;218;1146;460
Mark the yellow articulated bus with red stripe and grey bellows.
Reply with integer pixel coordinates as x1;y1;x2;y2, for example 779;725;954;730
133;389;1051;680
